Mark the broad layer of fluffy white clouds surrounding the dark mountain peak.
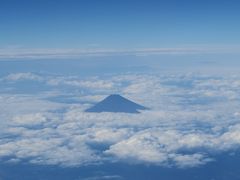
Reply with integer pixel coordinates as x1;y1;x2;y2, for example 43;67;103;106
0;74;240;168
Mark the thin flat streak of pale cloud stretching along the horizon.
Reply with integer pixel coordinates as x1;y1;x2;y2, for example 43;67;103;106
0;46;240;59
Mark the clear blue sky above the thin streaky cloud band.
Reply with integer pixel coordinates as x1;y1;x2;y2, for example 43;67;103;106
0;0;240;48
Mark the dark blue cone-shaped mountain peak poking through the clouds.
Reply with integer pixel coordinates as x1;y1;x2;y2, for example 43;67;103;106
85;94;147;113
